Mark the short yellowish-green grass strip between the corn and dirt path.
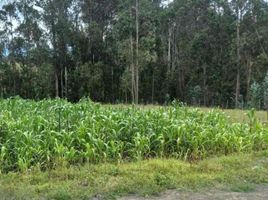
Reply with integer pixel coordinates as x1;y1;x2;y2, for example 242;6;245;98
0;151;268;200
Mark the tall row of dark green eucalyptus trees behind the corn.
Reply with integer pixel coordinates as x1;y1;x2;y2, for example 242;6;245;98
0;0;268;107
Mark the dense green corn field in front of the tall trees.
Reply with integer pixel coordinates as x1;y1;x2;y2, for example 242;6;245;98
0;98;268;172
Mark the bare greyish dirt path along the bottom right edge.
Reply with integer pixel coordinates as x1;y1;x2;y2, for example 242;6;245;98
120;186;268;200
